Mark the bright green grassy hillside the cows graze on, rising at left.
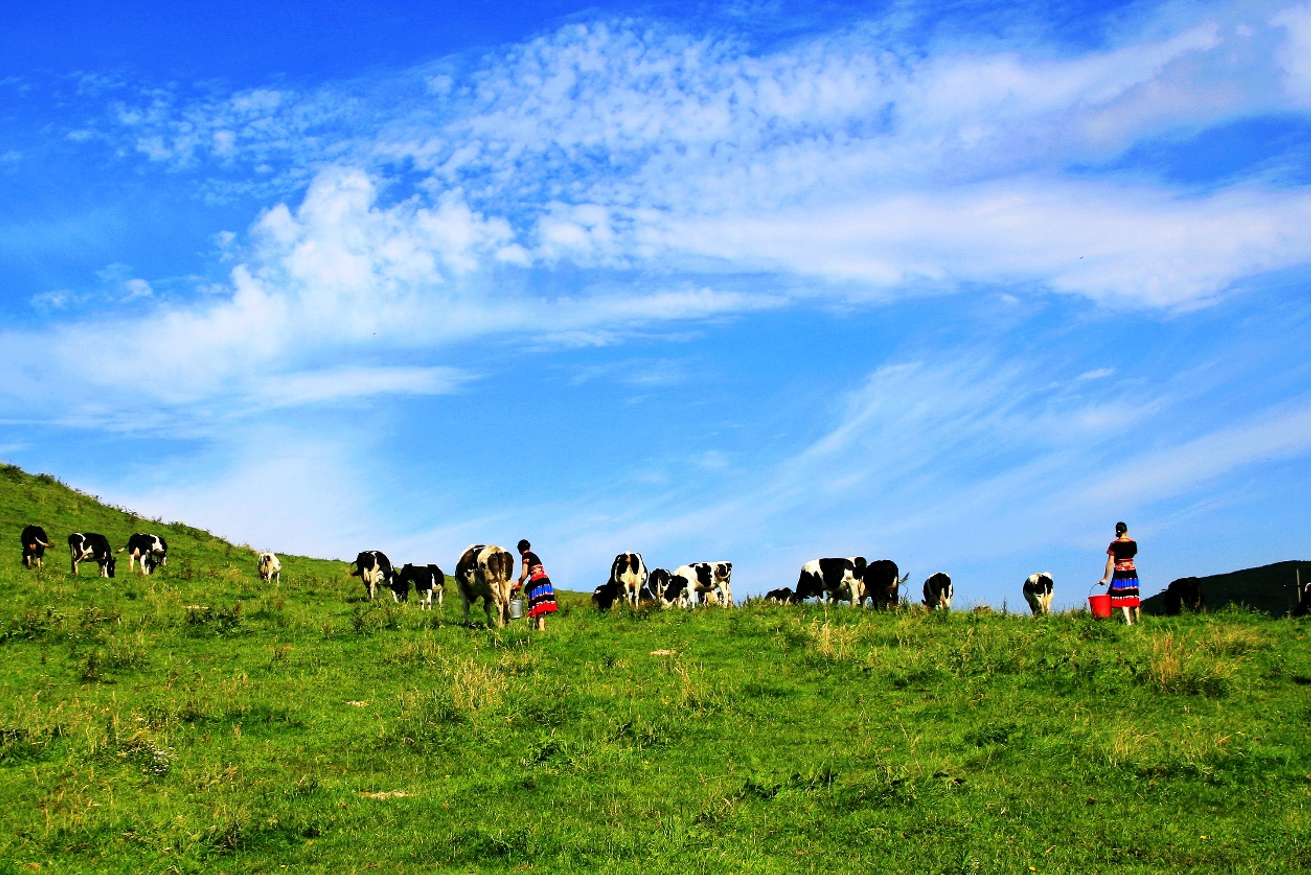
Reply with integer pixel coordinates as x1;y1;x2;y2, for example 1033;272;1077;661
0;468;1311;874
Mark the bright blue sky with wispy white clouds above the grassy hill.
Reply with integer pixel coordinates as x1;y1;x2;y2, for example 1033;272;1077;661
0;1;1311;605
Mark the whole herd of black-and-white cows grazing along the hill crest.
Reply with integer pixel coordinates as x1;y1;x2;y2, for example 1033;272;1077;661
22;526;1311;626
